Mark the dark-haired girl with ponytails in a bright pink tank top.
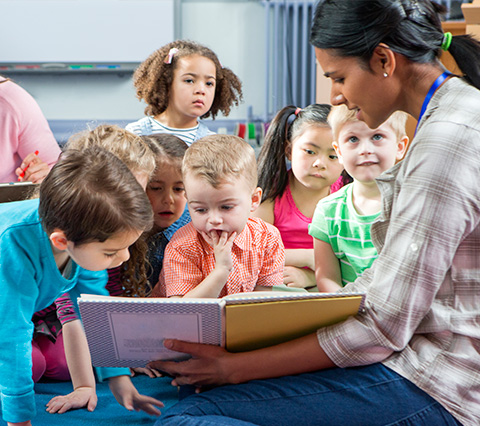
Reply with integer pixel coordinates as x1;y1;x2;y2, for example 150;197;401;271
255;104;343;289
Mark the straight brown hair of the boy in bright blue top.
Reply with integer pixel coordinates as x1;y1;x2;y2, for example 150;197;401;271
39;146;153;245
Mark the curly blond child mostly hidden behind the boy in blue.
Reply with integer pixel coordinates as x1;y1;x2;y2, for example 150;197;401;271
33;124;159;413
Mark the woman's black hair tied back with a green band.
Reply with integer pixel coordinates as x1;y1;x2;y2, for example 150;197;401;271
310;0;480;88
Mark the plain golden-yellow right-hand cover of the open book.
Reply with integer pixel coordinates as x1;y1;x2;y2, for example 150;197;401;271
225;295;362;352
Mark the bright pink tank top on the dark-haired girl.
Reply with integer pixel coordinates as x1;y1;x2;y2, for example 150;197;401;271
273;184;313;249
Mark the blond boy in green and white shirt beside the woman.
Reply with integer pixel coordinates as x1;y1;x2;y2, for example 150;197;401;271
309;105;408;292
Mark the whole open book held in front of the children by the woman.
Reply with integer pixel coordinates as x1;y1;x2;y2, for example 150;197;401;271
78;291;365;367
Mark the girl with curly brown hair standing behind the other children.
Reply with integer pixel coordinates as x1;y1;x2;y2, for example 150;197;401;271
126;40;243;145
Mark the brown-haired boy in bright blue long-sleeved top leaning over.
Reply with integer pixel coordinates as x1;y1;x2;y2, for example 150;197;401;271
0;147;162;426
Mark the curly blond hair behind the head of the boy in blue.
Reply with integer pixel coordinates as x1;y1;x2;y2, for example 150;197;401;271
65;124;156;177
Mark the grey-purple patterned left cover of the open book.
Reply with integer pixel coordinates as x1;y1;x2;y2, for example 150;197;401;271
78;294;224;367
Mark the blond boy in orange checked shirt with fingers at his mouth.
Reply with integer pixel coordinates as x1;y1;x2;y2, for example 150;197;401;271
155;135;285;297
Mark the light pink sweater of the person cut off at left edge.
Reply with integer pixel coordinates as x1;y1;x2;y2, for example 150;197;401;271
0;77;60;182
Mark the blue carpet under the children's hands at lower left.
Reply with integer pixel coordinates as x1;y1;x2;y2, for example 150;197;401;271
0;376;178;426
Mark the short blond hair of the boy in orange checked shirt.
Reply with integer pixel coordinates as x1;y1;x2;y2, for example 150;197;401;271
182;135;258;191
